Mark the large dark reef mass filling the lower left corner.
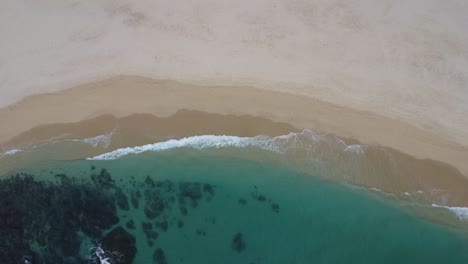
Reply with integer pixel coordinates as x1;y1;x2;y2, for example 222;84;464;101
0;172;119;263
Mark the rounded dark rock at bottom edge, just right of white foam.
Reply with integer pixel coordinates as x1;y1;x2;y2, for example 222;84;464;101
102;226;137;264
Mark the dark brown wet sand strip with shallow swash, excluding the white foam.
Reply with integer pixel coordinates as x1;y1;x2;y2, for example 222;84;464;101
0;106;468;209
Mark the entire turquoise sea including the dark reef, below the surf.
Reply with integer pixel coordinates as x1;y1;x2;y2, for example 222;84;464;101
0;150;468;264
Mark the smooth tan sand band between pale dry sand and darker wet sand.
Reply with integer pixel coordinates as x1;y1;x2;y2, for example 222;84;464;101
0;76;468;177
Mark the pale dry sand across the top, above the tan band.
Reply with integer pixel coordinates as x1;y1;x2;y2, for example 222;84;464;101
0;0;468;146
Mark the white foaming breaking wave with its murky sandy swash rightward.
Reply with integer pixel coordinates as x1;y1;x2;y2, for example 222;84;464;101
88;130;468;221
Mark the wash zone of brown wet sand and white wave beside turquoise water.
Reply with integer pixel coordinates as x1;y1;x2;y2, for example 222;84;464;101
0;110;468;228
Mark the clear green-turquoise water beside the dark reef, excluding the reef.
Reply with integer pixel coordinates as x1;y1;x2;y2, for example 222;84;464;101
0;150;468;264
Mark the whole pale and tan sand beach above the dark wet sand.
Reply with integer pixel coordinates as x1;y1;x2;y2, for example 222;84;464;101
0;0;468;178
